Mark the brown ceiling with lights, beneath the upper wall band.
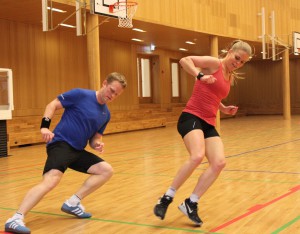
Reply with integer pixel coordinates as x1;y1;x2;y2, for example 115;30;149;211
0;0;296;59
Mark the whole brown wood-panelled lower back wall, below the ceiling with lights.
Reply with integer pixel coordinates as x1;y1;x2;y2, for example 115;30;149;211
0;20;300;119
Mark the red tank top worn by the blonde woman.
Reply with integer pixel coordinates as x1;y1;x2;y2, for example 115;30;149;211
183;63;230;126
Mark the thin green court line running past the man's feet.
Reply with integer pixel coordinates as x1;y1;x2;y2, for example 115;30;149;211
0;207;221;234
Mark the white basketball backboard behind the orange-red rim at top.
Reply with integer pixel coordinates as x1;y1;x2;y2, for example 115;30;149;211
91;0;127;18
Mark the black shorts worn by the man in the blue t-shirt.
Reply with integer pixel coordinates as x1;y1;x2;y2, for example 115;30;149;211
43;141;104;174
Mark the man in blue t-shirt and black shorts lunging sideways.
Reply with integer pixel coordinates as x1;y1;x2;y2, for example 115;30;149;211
5;72;127;233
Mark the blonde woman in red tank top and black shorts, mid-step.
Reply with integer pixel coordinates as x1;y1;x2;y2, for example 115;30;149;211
154;40;252;226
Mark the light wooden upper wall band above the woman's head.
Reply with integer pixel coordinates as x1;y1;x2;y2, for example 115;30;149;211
134;0;300;42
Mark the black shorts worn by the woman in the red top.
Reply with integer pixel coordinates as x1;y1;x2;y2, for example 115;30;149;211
177;112;220;138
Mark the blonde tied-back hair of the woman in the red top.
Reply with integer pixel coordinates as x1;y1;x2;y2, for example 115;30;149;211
220;40;253;83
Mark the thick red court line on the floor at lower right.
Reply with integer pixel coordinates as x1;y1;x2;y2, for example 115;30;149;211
210;185;300;232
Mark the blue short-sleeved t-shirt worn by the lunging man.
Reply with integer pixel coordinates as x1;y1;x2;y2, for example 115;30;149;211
49;89;110;150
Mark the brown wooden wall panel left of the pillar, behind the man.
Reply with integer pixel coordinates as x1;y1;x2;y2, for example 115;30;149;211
0;20;88;116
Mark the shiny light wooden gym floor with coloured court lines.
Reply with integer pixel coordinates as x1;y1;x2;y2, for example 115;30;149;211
0;116;300;234
